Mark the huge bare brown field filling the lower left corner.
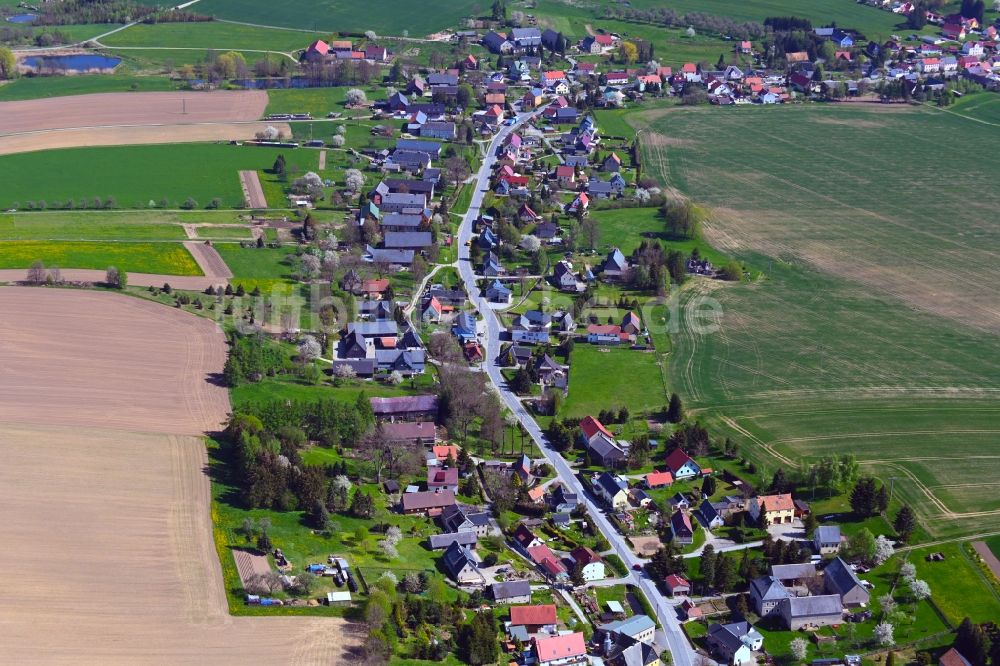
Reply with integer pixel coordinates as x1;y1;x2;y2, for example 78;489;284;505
0;287;361;666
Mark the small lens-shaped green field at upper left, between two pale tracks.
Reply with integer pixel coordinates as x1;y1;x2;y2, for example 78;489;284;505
101;21;329;53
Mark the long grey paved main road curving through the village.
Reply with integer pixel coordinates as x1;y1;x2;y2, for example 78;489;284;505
458;107;697;666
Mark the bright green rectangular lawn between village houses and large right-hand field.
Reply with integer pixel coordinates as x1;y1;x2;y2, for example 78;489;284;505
559;344;666;417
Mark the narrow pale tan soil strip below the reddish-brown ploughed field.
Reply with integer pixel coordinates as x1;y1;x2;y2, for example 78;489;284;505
0;121;291;155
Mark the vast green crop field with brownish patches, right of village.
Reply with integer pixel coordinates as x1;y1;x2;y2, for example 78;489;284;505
644;106;1000;536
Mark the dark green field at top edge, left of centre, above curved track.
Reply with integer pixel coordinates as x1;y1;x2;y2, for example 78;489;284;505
192;0;486;37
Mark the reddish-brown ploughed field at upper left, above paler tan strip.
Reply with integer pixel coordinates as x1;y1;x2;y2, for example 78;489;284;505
0;90;267;134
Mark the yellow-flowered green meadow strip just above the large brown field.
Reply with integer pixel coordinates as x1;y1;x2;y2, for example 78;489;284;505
0;241;202;275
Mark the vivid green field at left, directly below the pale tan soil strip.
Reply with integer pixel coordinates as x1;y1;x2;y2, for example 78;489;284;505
0;144;315;209
